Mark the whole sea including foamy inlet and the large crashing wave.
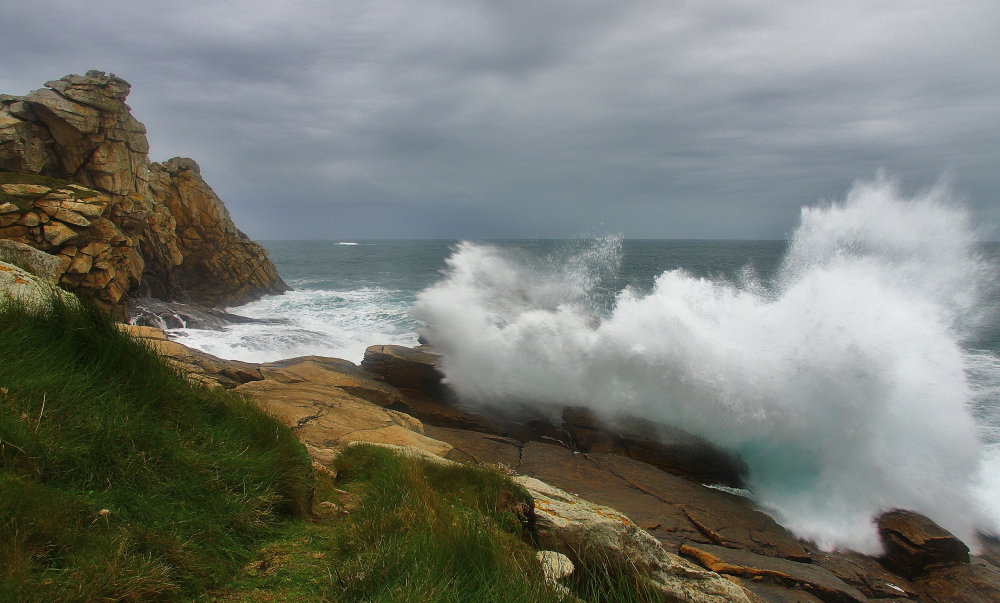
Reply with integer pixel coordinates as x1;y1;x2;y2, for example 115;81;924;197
168;181;1000;553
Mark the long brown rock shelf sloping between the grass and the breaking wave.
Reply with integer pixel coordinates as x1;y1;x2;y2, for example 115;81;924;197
103;326;1000;603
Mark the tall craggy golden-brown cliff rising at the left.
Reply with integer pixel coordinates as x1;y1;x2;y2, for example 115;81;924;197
0;71;288;311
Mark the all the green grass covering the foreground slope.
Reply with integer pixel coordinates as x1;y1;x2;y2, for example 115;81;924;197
0;296;672;603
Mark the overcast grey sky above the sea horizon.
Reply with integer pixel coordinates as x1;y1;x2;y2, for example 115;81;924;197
0;0;1000;240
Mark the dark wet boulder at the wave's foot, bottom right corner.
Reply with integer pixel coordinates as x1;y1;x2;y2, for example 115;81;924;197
878;510;969;579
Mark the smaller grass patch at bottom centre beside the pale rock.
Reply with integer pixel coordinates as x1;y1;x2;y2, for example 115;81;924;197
204;445;661;603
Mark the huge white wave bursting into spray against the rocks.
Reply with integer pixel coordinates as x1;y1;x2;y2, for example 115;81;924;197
414;179;1000;553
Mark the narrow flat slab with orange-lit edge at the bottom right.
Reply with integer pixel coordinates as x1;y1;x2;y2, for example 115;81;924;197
680;544;868;603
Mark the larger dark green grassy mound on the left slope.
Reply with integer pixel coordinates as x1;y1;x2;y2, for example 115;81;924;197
0;304;313;602
